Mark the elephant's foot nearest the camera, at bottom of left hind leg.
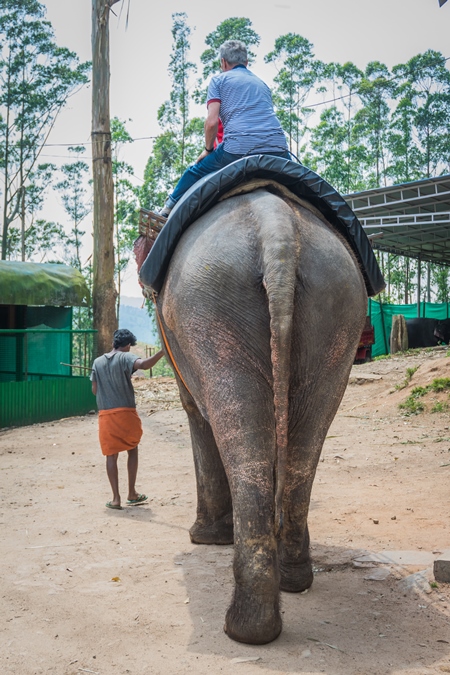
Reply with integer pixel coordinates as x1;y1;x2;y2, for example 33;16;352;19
224;588;282;645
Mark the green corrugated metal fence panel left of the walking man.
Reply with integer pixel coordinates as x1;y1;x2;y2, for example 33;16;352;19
0;377;97;428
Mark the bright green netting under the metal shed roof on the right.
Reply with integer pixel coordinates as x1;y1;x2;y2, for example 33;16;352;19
368;298;450;356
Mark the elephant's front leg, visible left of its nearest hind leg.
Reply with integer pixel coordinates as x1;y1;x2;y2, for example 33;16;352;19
184;396;233;545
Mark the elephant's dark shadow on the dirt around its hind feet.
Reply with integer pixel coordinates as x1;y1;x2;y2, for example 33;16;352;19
175;543;450;675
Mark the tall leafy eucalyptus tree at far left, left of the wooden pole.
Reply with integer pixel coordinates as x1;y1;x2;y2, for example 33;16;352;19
0;0;90;259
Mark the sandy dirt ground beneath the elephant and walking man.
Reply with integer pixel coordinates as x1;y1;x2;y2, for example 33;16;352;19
0;348;450;675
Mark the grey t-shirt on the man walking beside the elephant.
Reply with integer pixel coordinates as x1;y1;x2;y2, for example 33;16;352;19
91;352;139;410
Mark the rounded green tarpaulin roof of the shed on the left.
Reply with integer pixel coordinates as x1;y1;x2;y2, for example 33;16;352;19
0;260;90;307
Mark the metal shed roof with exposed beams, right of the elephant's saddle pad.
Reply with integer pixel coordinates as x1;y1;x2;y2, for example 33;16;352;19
344;174;450;265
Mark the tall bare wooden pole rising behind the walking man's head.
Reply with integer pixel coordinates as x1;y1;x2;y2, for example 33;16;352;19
92;0;119;354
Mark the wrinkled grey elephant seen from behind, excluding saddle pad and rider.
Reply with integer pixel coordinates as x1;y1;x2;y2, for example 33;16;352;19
153;189;367;644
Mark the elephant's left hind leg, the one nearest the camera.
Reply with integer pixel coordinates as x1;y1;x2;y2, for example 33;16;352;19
213;398;282;644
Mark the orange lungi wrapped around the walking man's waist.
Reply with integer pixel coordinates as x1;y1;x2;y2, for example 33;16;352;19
98;408;142;455
